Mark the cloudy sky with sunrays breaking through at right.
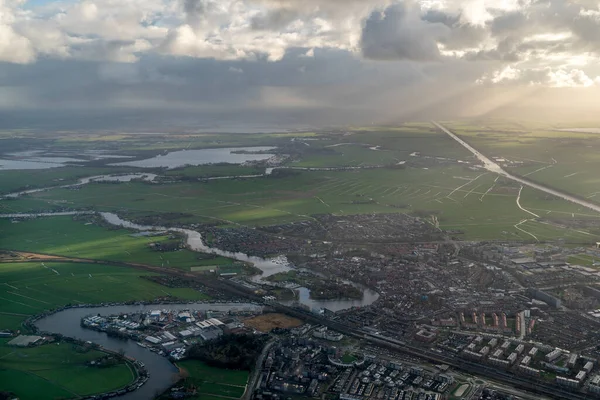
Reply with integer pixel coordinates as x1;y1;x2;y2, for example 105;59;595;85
0;0;600;125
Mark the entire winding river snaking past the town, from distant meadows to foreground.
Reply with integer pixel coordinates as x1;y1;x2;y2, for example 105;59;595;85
0;174;379;400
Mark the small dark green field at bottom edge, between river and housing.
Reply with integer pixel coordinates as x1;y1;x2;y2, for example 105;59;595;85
177;360;249;400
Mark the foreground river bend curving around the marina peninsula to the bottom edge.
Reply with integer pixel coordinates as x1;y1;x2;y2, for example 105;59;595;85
35;303;261;400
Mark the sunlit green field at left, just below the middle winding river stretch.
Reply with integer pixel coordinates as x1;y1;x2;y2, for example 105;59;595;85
0;216;233;271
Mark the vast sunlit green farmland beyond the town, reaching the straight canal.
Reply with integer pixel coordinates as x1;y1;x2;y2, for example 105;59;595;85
0;121;600;241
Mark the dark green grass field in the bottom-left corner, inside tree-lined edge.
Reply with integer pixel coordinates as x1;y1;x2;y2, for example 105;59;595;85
0;343;134;400
